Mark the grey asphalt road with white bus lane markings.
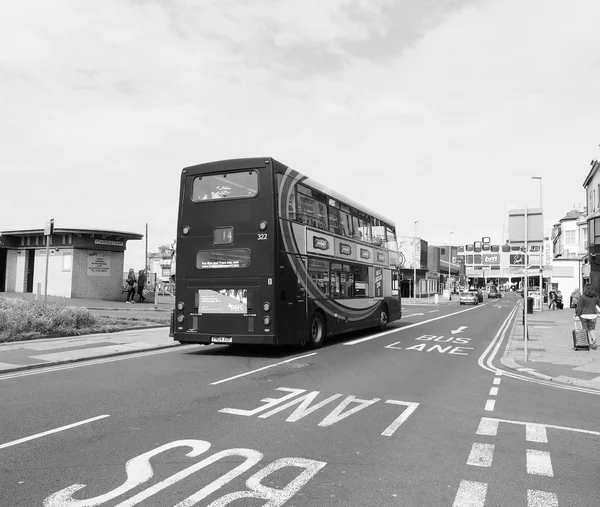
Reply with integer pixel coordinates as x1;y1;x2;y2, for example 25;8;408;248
0;296;600;507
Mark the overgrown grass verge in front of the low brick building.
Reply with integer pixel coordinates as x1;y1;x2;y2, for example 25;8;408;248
0;299;165;342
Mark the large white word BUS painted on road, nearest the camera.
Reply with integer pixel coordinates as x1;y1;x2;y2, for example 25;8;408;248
44;439;327;507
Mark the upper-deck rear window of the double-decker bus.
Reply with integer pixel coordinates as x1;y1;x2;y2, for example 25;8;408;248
192;170;258;202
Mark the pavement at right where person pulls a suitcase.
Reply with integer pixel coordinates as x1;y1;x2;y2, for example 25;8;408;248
501;303;600;390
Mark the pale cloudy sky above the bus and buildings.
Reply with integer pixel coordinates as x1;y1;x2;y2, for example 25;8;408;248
0;0;600;269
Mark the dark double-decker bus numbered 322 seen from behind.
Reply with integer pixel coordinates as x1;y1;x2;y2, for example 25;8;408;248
171;158;402;348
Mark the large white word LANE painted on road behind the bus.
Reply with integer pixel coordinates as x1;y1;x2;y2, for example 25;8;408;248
219;387;419;437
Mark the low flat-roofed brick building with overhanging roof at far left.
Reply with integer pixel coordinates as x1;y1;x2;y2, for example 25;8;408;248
0;229;144;301
